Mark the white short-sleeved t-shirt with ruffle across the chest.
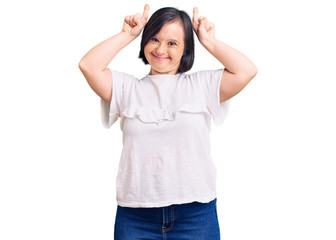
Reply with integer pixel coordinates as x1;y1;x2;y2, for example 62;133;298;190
101;69;229;207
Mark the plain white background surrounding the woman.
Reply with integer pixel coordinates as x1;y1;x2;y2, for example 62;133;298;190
0;0;336;240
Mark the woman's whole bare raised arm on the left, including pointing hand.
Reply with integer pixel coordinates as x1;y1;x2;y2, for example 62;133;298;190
79;4;149;102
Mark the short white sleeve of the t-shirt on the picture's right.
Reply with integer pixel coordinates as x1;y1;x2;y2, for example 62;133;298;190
196;69;230;126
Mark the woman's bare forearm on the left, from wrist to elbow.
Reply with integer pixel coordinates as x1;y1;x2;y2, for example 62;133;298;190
79;31;135;71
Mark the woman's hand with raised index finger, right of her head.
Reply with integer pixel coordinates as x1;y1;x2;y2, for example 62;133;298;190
193;7;215;46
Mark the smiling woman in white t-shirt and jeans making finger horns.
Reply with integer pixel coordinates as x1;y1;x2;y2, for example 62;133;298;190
79;5;257;240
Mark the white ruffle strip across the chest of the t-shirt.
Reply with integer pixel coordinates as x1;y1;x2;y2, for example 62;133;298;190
121;104;211;124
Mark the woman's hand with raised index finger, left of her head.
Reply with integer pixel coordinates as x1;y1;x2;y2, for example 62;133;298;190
123;4;149;37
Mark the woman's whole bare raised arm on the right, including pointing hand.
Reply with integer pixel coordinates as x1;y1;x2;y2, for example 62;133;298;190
193;7;258;102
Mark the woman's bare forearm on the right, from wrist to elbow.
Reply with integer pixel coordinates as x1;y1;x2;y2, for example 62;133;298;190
203;38;257;75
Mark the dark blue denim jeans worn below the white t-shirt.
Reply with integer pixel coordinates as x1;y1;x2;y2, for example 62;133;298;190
114;199;220;240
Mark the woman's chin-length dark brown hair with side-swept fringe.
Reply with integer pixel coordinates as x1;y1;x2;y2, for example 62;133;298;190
139;7;195;73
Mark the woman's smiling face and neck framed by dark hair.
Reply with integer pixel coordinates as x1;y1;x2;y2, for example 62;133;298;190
144;21;184;75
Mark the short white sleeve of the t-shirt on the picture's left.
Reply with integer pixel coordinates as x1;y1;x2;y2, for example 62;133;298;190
100;71;130;128
